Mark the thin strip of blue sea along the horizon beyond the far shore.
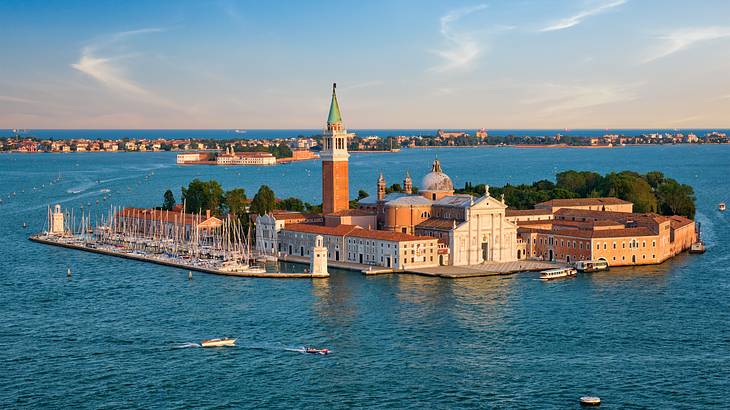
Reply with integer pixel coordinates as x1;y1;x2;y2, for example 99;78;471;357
0;128;730;139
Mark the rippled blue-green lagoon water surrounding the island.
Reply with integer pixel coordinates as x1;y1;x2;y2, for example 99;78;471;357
0;145;730;409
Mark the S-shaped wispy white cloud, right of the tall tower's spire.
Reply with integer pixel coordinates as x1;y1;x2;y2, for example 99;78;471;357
430;4;487;72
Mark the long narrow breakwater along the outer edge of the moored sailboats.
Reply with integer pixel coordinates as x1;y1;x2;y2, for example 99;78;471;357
28;235;329;279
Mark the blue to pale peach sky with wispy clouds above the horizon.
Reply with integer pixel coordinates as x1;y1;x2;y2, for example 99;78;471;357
0;0;730;129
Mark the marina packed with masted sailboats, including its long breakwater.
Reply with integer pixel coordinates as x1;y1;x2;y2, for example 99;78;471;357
28;205;328;279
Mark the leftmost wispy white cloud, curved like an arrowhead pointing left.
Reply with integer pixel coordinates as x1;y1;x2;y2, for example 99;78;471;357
71;27;169;105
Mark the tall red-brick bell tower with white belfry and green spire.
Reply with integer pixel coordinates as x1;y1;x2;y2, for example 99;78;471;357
320;83;350;214
